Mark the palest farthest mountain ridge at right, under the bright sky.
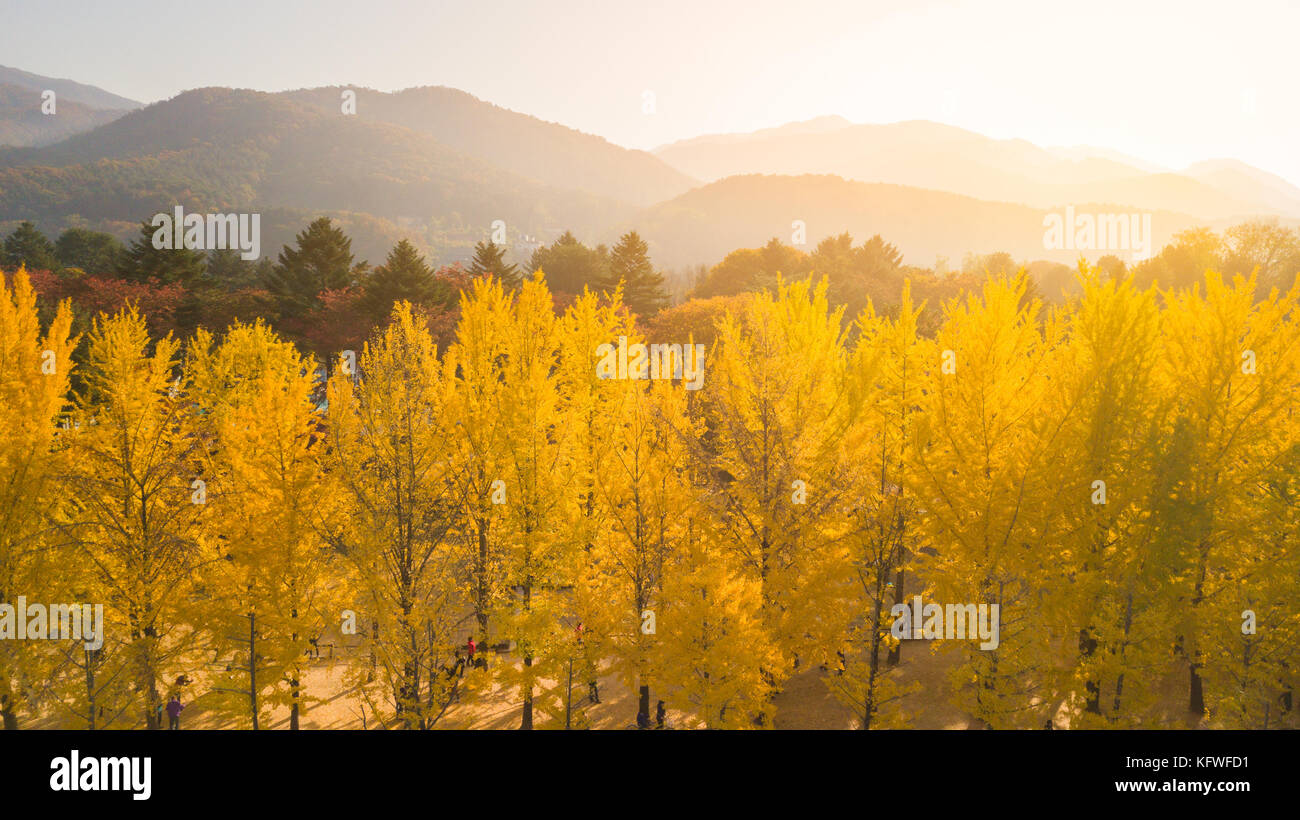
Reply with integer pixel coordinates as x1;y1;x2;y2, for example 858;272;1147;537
655;121;1300;220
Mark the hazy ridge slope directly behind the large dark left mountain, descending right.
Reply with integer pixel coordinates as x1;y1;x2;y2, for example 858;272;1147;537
286;86;698;205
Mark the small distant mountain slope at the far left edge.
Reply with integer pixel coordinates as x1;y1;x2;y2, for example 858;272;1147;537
0;65;140;147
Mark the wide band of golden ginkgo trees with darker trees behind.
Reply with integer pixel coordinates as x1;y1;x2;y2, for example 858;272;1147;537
0;211;1300;729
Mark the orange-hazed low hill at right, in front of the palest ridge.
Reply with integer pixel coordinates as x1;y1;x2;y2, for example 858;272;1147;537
624;174;1197;266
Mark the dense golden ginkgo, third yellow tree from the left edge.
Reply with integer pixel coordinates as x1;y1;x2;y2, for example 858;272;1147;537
190;322;342;729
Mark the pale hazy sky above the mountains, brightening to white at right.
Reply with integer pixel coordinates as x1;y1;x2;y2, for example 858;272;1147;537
0;0;1300;185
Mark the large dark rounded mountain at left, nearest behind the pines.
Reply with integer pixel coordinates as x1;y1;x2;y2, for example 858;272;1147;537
0;88;633;266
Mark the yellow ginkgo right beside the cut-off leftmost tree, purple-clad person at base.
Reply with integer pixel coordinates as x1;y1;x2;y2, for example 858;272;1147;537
66;307;207;729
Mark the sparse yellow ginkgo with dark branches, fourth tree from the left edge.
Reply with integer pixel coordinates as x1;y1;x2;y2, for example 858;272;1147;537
328;303;467;729
